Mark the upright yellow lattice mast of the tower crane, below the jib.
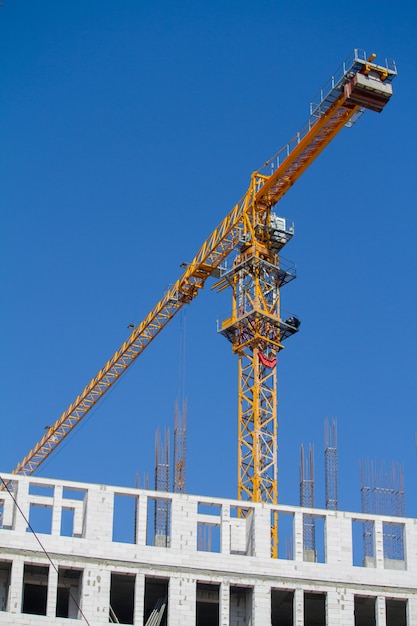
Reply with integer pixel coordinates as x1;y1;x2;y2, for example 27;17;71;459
215;214;299;503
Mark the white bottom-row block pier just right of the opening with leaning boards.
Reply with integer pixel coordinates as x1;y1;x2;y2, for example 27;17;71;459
168;576;197;626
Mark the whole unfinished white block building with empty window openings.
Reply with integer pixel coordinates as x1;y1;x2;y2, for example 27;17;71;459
0;475;417;626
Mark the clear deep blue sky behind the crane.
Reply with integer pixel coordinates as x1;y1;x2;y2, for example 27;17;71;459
0;0;417;516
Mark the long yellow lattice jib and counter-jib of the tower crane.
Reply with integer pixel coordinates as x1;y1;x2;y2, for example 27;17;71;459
8;50;397;476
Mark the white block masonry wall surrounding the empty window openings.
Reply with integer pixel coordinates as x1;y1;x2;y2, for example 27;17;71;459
0;474;417;626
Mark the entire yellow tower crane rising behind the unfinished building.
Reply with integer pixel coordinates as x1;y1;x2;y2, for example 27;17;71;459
13;49;397;532
